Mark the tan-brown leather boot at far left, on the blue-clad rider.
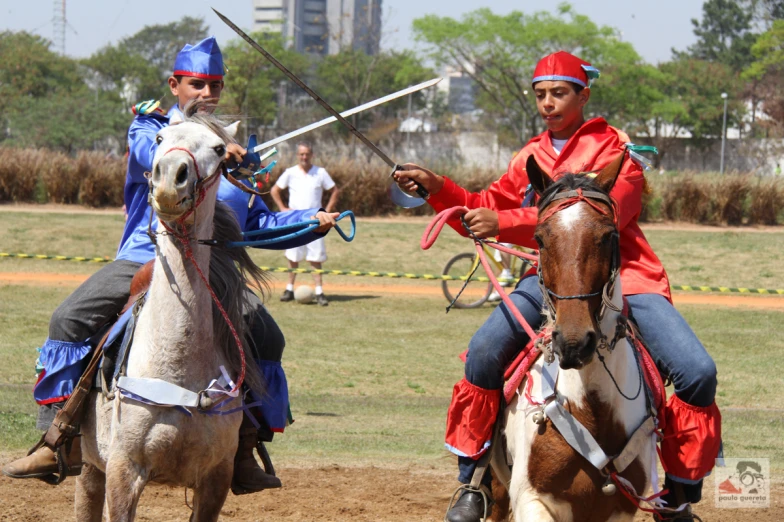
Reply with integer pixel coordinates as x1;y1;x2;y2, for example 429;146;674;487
3;437;82;484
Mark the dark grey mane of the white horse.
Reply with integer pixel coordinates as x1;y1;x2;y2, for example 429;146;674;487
179;101;269;394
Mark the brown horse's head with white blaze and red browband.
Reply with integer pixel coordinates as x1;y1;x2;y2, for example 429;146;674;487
526;154;623;369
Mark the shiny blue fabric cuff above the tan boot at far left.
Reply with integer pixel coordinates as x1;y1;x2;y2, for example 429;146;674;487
33;339;92;403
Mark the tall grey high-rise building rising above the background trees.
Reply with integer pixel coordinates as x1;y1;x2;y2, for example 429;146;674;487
253;0;382;54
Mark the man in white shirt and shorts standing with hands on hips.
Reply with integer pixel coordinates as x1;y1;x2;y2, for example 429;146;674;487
270;142;340;306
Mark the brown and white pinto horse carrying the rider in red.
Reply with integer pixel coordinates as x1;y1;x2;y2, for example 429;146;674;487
492;155;656;522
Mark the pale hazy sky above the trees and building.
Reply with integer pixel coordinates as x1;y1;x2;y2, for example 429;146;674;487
0;0;702;64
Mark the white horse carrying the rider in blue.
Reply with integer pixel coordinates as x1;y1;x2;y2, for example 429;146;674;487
75;106;261;522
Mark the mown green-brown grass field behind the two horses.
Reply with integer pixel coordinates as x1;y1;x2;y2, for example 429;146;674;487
0;213;784;471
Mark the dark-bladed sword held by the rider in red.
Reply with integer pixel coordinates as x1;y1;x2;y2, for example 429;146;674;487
212;7;430;208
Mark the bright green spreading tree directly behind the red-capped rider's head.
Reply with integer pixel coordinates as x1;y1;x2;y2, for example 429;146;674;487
414;4;660;143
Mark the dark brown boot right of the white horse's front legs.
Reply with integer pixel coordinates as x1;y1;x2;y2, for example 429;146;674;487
231;417;282;495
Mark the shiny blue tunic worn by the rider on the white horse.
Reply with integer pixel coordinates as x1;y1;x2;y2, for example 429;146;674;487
117;105;323;263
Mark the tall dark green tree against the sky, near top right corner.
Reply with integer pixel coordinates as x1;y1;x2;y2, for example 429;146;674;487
673;0;756;72
